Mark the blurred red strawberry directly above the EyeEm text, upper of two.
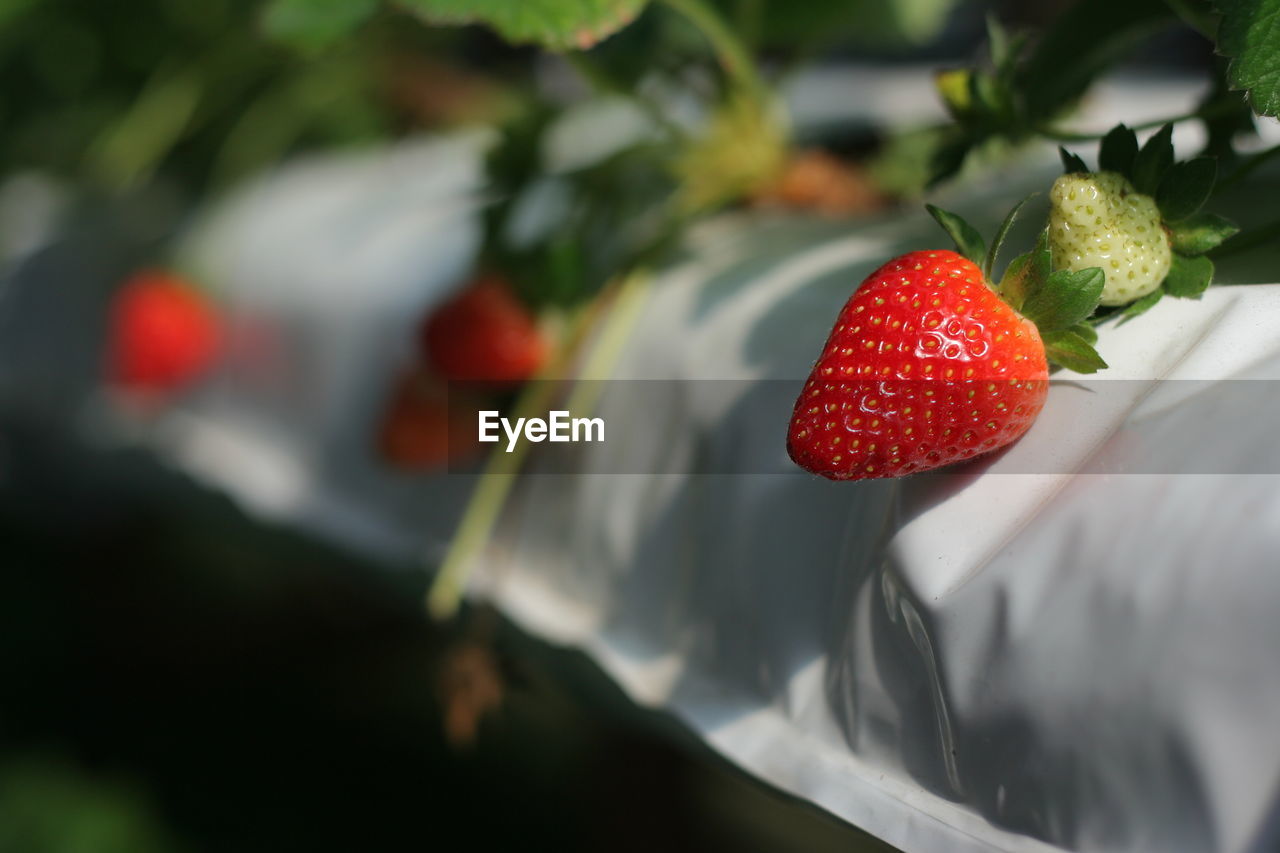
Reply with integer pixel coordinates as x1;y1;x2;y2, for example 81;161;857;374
422;275;547;383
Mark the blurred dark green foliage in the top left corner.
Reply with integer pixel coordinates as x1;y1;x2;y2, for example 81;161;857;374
0;0;409;190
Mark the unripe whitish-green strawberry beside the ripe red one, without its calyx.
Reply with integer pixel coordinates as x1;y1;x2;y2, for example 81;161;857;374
1048;172;1172;305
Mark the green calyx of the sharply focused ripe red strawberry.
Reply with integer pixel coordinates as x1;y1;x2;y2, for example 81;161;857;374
925;197;1107;373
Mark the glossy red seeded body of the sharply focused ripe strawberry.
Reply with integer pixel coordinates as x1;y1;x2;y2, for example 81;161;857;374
787;250;1048;480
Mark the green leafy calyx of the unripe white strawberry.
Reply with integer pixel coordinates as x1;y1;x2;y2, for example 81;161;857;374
1060;124;1239;318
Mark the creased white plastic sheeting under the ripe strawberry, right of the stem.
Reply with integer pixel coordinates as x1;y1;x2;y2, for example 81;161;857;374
474;207;1280;853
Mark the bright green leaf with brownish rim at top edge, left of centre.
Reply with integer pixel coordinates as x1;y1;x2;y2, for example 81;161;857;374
398;0;648;50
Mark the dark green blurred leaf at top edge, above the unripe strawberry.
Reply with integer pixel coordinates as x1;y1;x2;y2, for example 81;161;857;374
1018;0;1178;122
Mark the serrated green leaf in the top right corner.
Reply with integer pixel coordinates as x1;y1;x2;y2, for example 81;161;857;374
1216;0;1280;115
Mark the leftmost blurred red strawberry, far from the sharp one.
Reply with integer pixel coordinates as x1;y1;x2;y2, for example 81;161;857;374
108;269;221;393
